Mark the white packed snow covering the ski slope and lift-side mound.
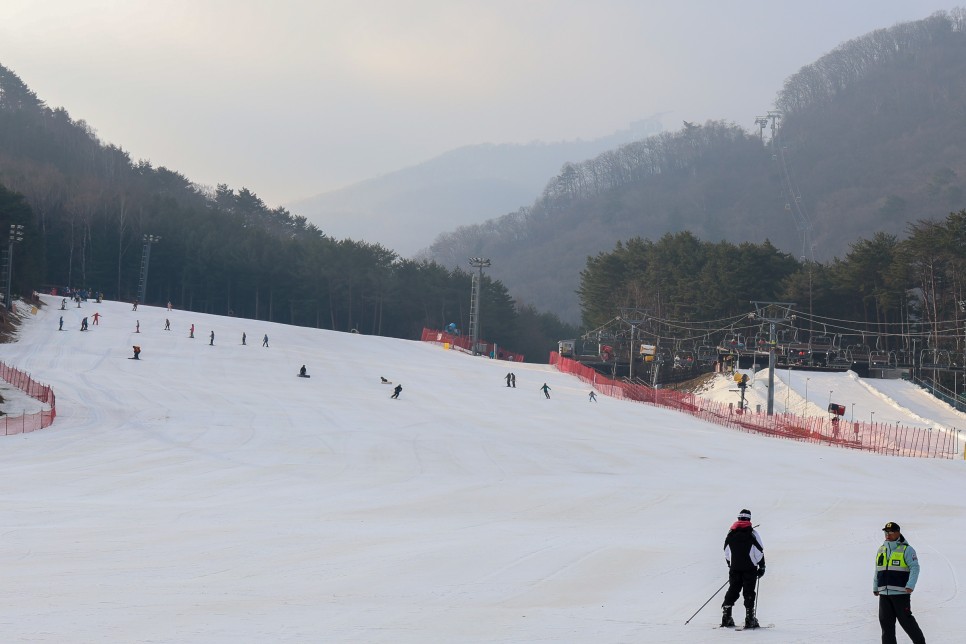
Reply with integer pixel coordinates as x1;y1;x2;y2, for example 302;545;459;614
0;298;966;644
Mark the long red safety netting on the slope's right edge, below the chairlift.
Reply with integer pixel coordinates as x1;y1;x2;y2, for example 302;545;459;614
550;352;966;459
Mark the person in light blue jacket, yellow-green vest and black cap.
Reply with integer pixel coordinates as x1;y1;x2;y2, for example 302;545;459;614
872;521;926;644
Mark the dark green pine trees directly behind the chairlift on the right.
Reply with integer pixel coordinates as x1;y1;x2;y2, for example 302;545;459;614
578;216;966;351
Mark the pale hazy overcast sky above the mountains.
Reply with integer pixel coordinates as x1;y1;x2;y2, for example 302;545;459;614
0;0;962;206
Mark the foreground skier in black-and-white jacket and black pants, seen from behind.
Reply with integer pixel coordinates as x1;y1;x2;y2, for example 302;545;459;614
721;510;765;628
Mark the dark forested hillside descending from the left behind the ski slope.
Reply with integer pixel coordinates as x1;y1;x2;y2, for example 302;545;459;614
0;67;576;360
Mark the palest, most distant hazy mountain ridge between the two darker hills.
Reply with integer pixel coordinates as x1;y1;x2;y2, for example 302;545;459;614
287;116;662;257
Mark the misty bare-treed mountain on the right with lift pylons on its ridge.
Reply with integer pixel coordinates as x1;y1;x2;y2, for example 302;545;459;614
428;9;966;320
